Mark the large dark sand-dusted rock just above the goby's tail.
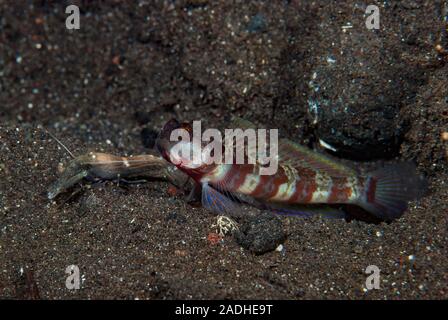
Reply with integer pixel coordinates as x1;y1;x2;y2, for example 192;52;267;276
308;48;414;159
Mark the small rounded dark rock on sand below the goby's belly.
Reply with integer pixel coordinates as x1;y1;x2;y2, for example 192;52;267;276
235;213;286;254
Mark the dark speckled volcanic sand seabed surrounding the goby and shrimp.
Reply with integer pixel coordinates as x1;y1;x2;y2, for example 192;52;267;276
0;0;448;299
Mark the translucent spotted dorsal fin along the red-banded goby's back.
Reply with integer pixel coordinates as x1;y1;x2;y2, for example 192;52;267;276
230;117;357;177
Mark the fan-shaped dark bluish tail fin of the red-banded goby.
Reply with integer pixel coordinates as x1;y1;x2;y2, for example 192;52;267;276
358;163;427;221
